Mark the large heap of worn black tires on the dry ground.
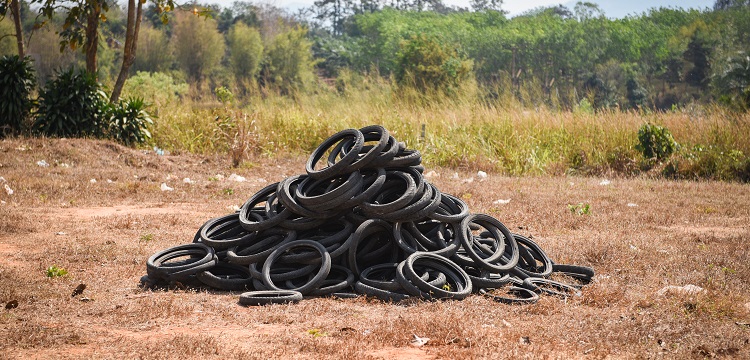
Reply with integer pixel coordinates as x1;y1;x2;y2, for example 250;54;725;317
141;125;594;305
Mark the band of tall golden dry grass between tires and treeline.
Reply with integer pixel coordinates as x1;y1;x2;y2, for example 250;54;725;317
147;83;750;179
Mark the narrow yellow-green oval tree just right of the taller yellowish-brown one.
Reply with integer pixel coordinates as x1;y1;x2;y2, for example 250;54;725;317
227;22;263;88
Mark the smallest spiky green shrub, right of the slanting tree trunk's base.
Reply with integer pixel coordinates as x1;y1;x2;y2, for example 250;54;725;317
107;98;154;146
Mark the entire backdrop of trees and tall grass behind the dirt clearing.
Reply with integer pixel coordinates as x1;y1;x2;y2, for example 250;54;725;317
0;0;750;181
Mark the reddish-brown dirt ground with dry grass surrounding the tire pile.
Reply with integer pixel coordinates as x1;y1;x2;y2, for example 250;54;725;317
0;139;750;359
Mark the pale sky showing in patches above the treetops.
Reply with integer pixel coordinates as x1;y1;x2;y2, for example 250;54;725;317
217;0;715;18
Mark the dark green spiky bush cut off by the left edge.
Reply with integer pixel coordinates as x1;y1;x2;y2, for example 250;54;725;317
0;55;36;137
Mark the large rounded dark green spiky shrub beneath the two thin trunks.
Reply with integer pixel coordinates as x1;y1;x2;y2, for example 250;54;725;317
33;68;108;137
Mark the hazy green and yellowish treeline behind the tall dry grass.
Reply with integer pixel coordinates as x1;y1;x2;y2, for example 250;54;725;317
0;0;750;109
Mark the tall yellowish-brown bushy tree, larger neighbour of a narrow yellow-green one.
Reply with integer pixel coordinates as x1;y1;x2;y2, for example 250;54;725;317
172;12;225;86
